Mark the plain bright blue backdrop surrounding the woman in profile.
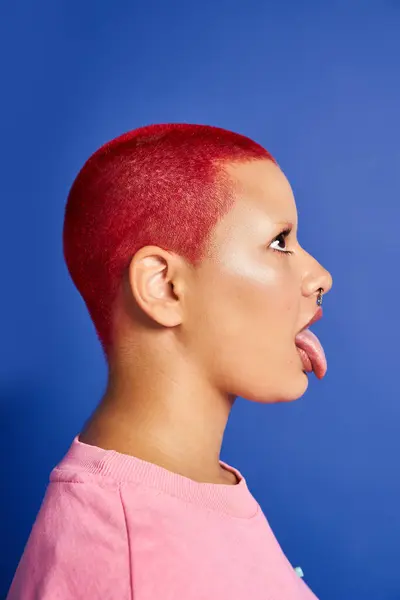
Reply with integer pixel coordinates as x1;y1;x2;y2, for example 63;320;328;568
0;0;400;600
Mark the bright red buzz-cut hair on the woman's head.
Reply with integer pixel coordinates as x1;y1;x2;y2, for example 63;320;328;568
63;124;275;356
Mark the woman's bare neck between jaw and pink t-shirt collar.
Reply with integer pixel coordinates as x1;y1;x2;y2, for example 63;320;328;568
80;354;235;484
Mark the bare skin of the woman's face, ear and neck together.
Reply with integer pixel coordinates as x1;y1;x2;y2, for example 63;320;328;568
80;160;332;485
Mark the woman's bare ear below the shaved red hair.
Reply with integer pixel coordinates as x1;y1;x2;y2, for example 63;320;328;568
128;246;184;327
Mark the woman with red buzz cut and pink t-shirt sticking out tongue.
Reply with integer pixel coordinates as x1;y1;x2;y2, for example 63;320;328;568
9;124;332;600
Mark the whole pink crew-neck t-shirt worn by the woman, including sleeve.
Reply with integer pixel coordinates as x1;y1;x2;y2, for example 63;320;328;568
8;438;316;600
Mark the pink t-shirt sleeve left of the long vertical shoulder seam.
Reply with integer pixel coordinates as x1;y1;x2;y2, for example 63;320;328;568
7;481;133;600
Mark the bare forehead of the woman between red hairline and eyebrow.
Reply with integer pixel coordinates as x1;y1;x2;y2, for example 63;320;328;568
226;160;297;226
